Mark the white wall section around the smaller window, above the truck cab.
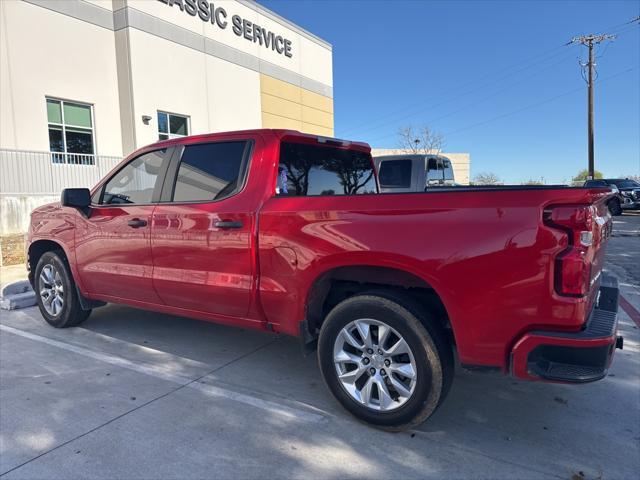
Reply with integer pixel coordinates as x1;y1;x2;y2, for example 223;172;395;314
129;29;261;146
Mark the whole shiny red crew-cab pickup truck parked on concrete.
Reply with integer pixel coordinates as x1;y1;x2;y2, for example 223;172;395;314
28;130;622;429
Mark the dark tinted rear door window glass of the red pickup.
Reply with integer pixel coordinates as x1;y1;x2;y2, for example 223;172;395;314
173;142;247;202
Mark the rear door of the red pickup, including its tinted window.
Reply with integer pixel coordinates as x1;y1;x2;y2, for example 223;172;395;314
151;137;257;317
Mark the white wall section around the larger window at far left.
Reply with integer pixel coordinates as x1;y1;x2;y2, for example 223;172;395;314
0;1;122;156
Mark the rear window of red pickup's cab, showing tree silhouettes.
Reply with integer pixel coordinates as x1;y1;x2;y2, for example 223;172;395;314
276;142;376;196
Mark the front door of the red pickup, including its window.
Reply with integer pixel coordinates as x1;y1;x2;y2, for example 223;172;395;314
76;149;172;303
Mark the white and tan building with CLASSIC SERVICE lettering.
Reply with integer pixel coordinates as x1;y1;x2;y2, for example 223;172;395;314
0;0;333;239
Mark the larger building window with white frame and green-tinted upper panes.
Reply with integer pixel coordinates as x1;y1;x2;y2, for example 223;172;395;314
47;98;95;165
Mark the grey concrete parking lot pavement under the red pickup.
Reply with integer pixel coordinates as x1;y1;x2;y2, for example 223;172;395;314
0;214;640;479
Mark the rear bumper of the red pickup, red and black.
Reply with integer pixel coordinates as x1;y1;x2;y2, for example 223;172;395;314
510;274;622;383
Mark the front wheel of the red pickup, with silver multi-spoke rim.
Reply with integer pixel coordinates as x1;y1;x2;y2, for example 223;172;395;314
34;251;91;328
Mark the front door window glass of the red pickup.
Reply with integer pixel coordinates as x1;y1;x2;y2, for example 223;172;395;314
101;149;167;205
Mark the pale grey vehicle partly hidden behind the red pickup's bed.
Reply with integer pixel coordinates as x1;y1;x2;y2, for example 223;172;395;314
373;154;455;193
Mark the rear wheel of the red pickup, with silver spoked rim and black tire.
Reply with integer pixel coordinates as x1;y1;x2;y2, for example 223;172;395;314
318;292;453;431
